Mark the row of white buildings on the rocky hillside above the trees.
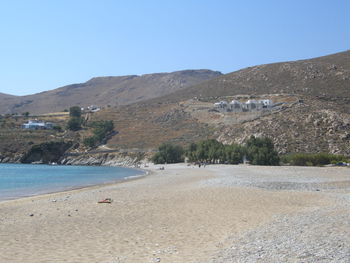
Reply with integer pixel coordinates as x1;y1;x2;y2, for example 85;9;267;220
214;100;273;112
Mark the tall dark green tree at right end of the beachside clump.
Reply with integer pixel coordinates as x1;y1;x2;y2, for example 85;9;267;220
246;136;280;165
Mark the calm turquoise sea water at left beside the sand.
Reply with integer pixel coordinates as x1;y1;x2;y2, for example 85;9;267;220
0;164;143;200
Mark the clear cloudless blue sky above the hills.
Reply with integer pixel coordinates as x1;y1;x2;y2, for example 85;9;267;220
0;0;350;95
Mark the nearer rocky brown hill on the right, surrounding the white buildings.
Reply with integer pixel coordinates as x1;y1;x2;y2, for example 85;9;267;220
89;51;350;155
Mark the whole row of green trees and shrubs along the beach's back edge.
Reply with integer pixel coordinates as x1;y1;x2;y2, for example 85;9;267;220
152;136;350;166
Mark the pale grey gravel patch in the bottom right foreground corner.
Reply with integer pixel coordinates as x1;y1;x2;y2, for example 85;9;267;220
210;205;350;263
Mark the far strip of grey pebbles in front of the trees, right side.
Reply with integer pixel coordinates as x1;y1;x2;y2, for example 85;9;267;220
202;165;350;191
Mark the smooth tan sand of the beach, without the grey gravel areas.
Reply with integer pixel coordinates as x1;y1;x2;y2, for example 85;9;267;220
0;164;350;263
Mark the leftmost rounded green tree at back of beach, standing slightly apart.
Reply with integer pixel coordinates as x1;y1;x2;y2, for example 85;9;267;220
152;143;184;164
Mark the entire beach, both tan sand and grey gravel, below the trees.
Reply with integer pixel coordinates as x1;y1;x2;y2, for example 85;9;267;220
0;164;350;263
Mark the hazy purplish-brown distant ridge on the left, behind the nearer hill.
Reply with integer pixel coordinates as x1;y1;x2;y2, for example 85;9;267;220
0;70;221;113
